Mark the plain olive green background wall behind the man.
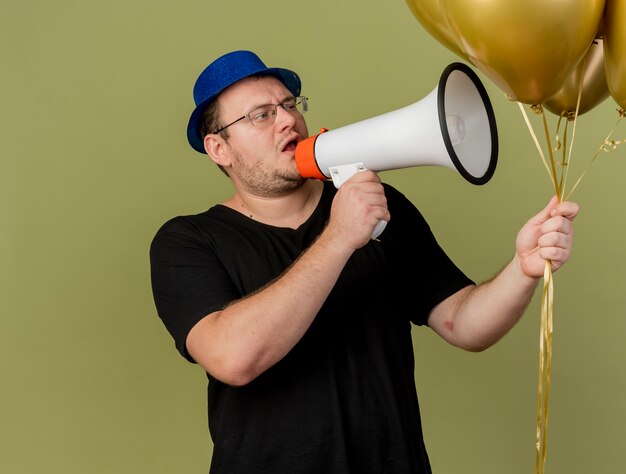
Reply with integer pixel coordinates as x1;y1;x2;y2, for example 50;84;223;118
0;0;626;474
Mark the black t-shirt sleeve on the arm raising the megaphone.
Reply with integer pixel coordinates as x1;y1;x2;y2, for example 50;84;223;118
150;217;240;362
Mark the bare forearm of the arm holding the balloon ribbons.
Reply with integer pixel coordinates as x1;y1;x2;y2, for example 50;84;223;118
429;256;539;351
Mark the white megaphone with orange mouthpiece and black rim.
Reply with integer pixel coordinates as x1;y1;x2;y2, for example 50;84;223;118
295;62;498;238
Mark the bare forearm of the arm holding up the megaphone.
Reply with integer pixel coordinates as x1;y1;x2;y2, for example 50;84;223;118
187;229;354;385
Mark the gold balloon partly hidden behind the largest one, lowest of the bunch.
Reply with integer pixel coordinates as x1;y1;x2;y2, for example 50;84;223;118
543;39;609;116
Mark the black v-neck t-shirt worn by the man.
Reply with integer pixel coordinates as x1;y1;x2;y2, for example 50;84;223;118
150;182;472;474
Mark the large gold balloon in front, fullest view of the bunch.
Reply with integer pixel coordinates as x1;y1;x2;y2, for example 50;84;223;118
441;0;605;105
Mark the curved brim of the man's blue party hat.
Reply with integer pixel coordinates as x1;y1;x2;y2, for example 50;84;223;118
187;68;301;154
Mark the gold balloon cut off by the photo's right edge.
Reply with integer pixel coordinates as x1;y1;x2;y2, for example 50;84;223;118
604;0;626;109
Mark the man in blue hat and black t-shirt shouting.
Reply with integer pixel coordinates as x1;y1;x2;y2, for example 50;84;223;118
151;51;578;474
